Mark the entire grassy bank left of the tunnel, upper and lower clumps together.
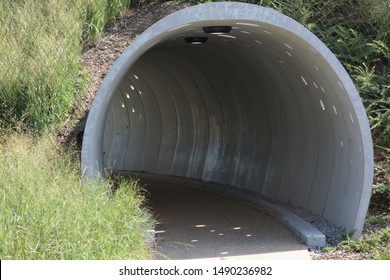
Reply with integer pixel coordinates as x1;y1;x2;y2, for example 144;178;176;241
0;0;152;260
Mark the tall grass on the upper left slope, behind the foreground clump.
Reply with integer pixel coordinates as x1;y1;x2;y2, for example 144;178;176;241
0;0;130;132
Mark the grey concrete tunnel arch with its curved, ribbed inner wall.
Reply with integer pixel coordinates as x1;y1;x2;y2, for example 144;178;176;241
82;2;373;245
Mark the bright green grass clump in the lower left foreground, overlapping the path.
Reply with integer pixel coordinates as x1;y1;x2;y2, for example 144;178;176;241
0;133;152;260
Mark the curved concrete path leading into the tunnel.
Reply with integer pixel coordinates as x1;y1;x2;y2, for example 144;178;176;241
142;180;310;260
